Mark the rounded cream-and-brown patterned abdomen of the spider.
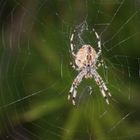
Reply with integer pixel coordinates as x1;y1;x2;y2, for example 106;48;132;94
75;45;96;69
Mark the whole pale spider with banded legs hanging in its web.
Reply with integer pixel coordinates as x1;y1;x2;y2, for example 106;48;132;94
68;28;111;105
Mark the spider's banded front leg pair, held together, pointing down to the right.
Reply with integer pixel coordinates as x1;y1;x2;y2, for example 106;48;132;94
91;69;111;104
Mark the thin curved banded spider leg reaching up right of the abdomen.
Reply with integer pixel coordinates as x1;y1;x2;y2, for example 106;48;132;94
92;28;102;60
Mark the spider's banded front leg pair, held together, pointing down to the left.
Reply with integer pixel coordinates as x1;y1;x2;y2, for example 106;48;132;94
68;70;86;105
